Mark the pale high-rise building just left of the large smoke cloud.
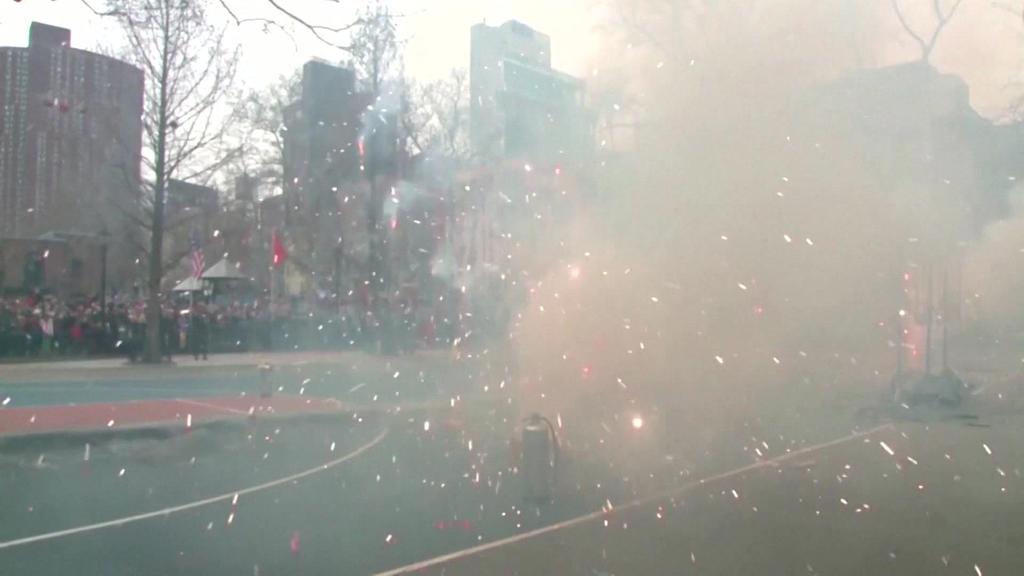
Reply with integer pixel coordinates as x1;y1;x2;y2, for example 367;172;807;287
469;20;592;161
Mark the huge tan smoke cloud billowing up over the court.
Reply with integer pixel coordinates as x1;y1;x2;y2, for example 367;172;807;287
514;0;1003;469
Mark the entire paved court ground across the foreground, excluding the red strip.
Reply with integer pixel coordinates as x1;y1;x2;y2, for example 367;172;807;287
0;342;1024;576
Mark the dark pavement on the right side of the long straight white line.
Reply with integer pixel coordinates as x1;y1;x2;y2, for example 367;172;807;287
385;416;1024;576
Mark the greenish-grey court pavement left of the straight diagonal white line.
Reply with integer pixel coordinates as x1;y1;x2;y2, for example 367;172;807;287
0;358;629;575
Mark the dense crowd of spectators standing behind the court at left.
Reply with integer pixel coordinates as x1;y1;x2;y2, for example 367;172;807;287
0;284;493;361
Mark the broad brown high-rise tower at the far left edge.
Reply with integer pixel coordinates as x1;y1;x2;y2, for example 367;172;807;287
0;23;143;237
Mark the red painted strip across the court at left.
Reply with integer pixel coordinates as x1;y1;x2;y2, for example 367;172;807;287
0;395;342;437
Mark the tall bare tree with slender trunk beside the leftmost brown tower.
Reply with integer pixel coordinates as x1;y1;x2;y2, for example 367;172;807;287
95;0;238;362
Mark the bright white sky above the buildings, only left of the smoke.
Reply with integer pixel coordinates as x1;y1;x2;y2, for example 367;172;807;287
0;0;597;85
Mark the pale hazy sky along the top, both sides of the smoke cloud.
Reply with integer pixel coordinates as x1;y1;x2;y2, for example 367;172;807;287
0;0;1024;118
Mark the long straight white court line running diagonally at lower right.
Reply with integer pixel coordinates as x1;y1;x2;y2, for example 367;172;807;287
375;424;892;576
